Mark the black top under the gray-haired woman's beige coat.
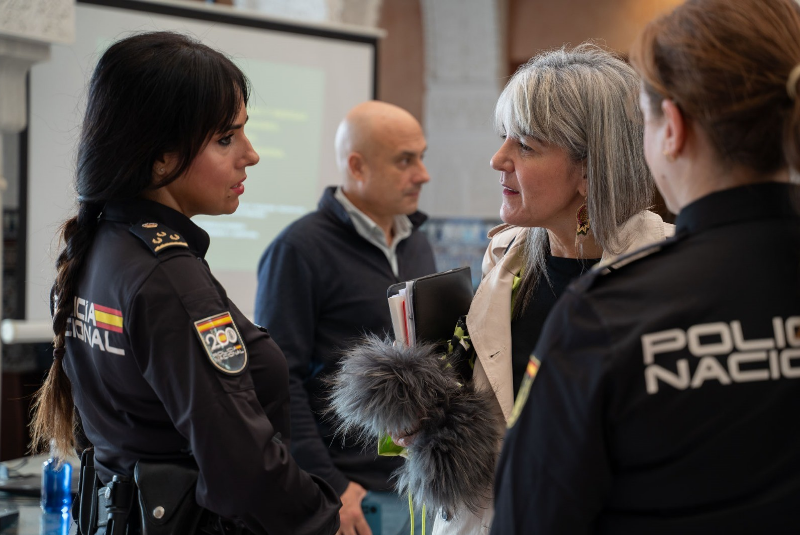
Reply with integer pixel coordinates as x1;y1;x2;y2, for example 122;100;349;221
511;256;600;394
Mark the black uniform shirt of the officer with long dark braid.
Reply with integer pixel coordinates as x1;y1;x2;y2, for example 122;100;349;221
64;200;339;534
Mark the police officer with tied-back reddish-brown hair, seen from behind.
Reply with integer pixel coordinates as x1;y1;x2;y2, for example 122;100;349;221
492;0;800;535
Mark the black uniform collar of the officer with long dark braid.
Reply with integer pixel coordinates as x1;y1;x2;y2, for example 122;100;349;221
101;199;211;257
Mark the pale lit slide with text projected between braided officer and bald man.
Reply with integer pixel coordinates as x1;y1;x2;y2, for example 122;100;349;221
193;59;325;271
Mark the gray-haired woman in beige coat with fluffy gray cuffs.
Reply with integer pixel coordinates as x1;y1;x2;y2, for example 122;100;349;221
333;44;672;534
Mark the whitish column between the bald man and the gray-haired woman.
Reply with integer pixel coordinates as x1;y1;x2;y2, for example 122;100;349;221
421;0;505;218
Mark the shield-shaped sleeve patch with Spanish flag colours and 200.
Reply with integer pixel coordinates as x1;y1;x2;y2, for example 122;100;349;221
194;312;247;375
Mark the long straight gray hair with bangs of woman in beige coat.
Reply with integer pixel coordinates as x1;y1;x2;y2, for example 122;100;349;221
495;43;653;317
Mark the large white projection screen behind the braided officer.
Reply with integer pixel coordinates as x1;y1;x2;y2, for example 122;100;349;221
25;0;380;320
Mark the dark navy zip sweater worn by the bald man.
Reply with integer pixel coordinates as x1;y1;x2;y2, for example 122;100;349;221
255;187;436;494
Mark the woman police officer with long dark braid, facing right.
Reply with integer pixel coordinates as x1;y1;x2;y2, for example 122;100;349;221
28;32;339;534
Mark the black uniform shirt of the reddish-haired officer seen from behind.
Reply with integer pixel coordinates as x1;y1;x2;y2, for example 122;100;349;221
492;183;800;535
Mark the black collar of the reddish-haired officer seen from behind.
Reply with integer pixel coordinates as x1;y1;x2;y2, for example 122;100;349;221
675;182;800;234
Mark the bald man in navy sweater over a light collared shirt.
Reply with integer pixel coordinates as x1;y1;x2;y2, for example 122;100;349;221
255;101;436;535
